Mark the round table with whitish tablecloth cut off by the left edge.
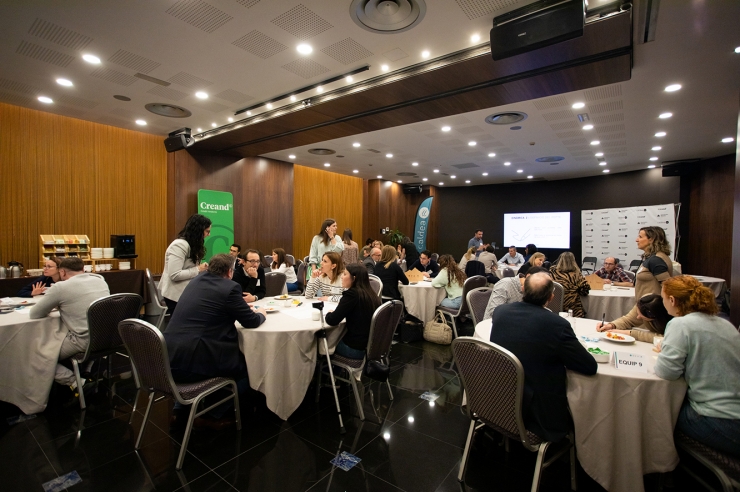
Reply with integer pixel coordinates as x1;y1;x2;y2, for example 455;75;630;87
0;298;67;415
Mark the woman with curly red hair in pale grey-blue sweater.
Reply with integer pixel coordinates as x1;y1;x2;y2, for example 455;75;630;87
655;275;740;458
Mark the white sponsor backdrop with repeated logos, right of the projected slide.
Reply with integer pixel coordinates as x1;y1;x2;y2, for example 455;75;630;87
581;203;676;268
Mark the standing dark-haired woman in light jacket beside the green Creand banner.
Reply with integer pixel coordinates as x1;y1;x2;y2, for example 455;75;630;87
159;214;211;314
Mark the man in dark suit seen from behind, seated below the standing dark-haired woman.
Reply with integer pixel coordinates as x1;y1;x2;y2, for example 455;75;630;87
164;254;266;422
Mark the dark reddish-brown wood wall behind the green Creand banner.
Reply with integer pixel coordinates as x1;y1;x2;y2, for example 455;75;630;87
168;150;293;262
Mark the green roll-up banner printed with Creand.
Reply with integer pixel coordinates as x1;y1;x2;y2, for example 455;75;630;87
198;190;234;261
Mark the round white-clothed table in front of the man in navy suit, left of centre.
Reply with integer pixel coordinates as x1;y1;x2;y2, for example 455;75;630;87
236;296;344;420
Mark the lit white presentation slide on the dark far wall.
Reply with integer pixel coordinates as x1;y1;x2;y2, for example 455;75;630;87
502;212;570;249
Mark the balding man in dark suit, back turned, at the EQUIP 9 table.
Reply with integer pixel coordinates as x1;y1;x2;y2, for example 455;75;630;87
491;273;596;441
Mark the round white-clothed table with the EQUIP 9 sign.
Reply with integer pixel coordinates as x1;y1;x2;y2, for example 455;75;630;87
474;318;686;492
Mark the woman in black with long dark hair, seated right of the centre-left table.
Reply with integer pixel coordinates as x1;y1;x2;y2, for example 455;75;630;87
326;266;382;359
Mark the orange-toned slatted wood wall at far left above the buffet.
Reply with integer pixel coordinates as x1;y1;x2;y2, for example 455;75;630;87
0;103;167;271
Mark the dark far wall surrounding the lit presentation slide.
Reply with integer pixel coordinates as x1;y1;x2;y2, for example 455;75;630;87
437;169;680;259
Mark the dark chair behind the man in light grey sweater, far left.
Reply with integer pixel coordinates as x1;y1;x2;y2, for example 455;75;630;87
70;294;143;410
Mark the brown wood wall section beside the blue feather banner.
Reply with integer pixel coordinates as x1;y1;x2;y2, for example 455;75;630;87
366;183;440;251
